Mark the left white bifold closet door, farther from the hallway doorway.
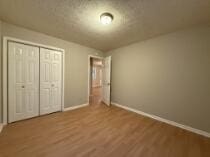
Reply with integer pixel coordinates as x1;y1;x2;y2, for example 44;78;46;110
8;42;39;122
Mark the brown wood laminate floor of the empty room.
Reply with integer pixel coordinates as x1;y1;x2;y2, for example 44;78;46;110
0;87;210;157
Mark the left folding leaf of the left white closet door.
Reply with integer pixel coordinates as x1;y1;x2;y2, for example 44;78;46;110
8;43;25;122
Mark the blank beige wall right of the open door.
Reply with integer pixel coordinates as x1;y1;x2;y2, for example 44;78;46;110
106;26;210;132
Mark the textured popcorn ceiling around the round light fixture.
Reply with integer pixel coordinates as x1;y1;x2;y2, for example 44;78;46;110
0;0;210;51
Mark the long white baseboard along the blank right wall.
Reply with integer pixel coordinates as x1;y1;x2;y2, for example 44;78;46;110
111;102;210;138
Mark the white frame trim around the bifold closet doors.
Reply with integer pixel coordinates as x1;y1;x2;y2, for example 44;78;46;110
2;36;65;125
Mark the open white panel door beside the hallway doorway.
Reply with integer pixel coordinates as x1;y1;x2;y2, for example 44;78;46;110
102;56;111;106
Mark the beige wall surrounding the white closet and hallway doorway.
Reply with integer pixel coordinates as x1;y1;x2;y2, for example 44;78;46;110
0;22;103;122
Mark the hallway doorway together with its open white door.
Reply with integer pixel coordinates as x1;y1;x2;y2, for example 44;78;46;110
87;55;111;106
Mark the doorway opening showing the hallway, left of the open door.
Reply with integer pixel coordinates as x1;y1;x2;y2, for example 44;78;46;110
89;57;103;105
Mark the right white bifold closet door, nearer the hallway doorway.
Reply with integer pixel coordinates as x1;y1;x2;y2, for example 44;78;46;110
40;48;62;115
